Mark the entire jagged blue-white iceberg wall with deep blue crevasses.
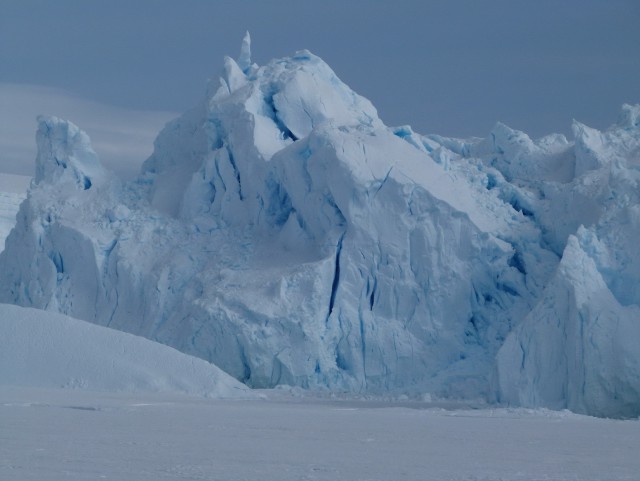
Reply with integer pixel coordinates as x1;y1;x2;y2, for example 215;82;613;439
0;38;640;415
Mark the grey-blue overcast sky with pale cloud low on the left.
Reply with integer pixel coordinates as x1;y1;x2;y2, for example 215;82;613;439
0;0;640;173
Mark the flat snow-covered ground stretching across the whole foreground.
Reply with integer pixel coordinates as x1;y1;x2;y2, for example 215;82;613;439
0;388;640;481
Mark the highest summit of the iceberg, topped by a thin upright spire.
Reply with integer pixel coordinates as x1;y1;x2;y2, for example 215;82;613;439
208;41;382;154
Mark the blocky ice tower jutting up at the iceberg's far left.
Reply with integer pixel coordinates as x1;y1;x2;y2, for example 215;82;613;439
35;115;104;190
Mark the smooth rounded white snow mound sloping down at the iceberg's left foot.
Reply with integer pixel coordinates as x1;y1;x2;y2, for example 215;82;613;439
0;304;251;398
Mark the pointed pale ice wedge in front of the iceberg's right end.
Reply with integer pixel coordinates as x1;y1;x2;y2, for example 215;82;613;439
497;228;640;417
